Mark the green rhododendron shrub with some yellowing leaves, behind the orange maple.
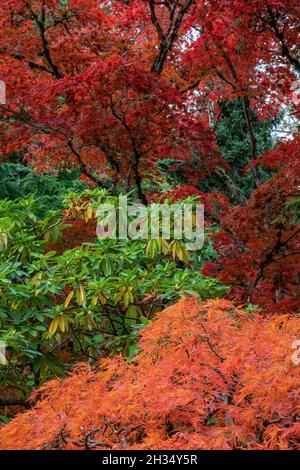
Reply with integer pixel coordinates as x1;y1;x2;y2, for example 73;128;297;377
0;190;224;396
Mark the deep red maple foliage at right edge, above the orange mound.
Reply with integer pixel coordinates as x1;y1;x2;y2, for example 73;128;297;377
204;138;300;313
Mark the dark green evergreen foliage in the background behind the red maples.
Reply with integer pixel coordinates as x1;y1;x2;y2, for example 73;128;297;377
159;100;281;204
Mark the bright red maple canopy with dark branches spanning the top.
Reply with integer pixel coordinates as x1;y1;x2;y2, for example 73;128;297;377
0;0;300;198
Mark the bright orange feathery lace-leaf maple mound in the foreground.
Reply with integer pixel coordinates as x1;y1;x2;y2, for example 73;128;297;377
0;298;300;450
